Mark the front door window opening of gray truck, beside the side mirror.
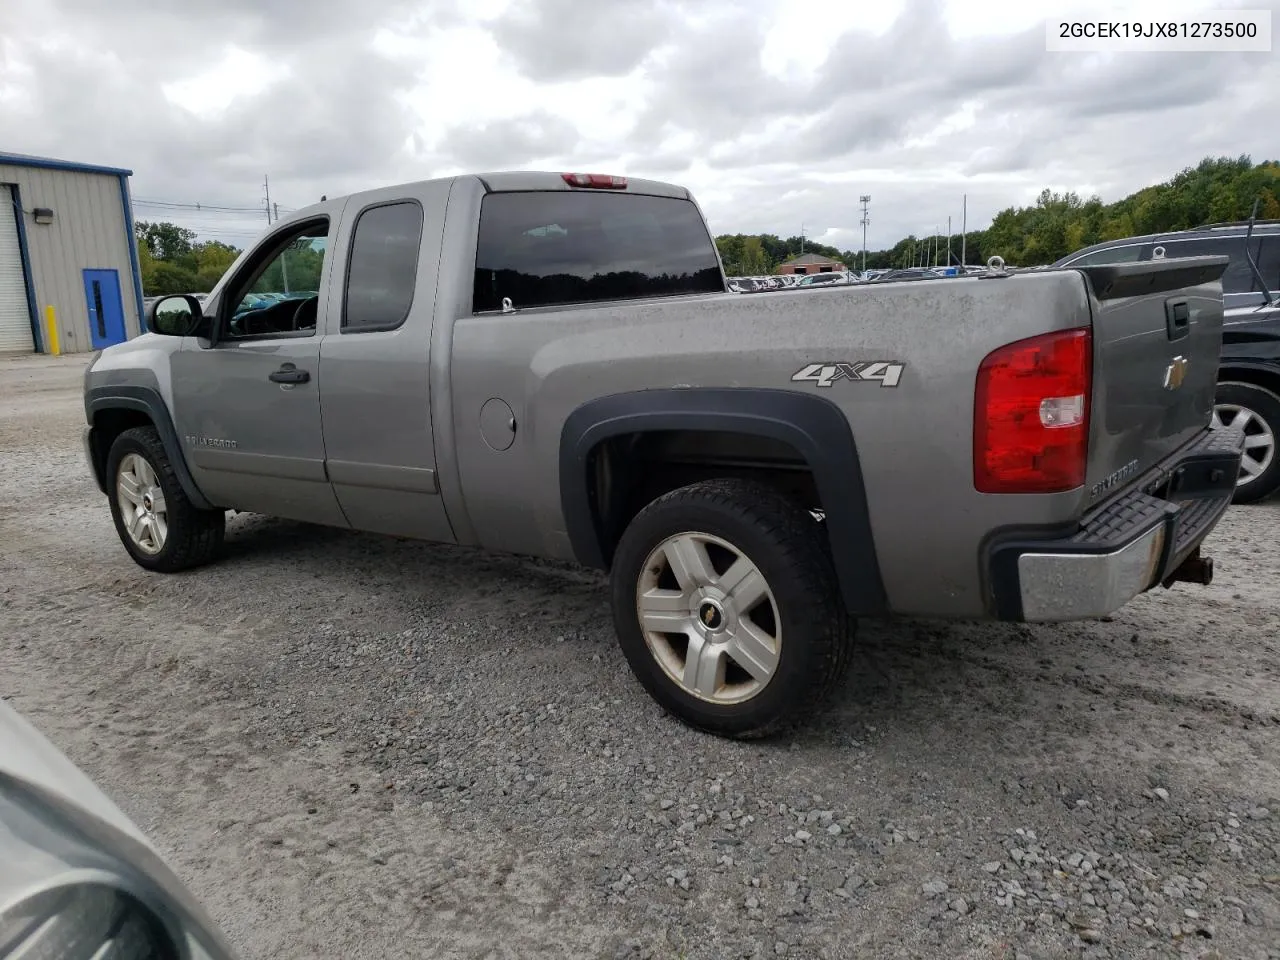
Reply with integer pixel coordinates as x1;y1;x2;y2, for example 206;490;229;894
224;218;329;339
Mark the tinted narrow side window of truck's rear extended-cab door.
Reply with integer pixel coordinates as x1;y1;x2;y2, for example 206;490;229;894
342;200;422;333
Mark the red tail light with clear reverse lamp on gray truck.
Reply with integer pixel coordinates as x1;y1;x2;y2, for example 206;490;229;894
973;328;1093;493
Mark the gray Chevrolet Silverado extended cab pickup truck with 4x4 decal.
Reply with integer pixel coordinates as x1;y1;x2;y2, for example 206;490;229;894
84;173;1242;736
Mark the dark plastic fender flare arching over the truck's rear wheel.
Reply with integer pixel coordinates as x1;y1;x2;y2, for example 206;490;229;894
559;387;888;616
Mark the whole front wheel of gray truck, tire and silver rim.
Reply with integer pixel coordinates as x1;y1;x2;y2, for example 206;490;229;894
106;426;227;573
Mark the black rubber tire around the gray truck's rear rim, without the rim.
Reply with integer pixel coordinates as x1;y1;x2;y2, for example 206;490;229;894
611;480;854;739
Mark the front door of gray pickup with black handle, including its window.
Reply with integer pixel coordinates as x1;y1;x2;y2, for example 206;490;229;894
173;216;347;526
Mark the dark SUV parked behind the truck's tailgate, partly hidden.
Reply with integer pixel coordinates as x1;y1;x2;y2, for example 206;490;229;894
1053;220;1280;503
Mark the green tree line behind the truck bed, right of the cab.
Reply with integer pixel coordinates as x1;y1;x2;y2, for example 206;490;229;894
716;156;1280;276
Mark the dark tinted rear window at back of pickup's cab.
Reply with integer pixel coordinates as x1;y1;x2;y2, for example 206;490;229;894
474;192;724;311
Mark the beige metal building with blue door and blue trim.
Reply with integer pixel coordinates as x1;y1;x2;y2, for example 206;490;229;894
0;154;142;353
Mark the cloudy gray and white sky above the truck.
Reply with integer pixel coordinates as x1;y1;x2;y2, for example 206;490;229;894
0;0;1280;250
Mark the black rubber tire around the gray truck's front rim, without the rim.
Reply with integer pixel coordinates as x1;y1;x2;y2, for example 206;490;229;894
106;426;227;573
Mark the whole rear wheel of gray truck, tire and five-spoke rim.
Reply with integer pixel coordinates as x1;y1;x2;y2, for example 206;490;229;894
611;480;852;737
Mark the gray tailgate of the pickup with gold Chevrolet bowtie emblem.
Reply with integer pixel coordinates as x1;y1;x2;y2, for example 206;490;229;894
1076;256;1228;503
